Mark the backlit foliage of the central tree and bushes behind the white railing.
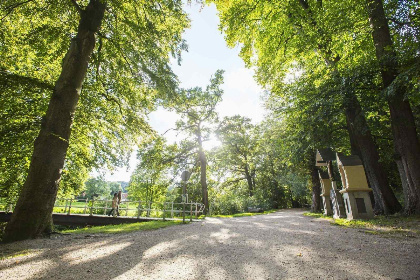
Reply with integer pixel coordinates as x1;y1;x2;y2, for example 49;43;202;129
129;71;223;210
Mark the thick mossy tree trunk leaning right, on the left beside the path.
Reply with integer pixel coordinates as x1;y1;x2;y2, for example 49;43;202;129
3;0;105;242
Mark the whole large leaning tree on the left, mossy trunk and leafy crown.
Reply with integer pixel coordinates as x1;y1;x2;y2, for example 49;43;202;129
1;0;188;241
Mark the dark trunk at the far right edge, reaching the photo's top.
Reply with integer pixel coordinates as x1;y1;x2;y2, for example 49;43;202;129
366;0;420;213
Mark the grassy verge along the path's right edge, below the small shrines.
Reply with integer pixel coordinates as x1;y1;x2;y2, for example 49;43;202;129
304;212;420;237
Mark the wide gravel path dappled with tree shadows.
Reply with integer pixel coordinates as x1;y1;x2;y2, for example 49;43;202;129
0;210;420;280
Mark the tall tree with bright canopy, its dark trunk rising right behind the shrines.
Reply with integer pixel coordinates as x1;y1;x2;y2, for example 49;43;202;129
210;0;401;213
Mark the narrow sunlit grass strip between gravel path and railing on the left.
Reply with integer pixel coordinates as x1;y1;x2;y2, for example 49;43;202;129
60;221;186;234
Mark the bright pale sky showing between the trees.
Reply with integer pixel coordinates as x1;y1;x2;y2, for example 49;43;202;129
105;3;264;181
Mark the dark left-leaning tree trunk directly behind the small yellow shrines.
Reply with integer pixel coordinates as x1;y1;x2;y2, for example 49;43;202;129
344;92;402;214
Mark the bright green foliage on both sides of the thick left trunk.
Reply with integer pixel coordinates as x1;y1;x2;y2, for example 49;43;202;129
0;0;189;200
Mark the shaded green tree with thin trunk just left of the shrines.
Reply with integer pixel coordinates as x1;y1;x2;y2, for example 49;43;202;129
262;79;349;212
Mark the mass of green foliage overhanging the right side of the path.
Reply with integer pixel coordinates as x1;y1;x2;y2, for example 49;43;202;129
206;0;419;213
